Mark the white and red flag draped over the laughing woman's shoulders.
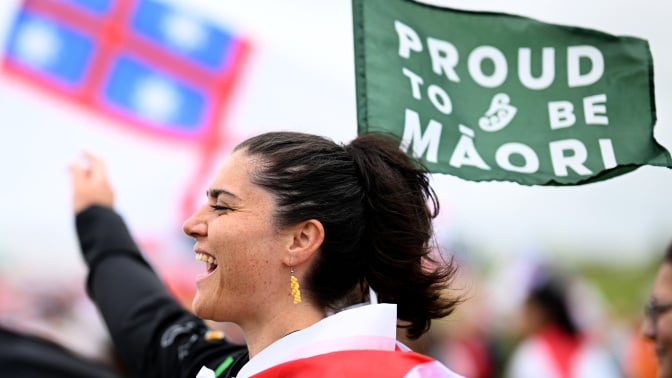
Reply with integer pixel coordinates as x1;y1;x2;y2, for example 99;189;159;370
196;303;462;378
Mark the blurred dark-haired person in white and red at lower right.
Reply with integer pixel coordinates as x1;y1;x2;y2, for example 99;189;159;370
506;272;623;378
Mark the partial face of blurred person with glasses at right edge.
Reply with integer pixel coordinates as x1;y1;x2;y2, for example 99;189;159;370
642;244;672;378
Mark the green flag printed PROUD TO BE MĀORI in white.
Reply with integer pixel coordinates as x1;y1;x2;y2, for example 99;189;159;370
353;0;672;185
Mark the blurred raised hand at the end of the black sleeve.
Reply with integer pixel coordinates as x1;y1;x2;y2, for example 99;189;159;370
70;152;114;214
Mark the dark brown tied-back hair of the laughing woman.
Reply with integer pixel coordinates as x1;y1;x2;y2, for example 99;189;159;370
236;132;460;338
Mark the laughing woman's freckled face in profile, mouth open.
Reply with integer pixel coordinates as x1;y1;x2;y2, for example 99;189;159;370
183;151;290;324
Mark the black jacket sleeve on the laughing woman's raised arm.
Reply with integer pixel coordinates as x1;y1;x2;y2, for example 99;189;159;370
76;206;247;377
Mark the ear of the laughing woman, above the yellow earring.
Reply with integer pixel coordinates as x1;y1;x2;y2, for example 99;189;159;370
284;219;324;266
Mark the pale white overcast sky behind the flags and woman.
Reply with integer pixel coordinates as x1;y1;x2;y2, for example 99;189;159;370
0;0;672;276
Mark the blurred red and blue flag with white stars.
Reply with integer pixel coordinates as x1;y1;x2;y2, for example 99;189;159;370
3;0;245;140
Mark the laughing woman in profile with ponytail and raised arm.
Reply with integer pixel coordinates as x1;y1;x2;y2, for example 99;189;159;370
71;132;459;378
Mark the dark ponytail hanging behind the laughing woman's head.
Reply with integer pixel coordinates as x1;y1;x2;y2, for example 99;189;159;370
346;134;459;338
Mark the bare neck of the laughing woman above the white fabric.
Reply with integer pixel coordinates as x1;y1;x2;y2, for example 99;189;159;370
240;302;326;358
